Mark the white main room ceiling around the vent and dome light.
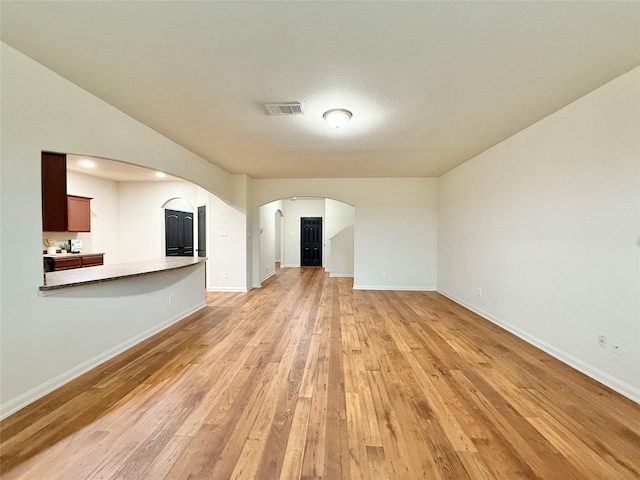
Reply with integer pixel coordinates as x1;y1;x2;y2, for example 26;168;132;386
1;0;640;178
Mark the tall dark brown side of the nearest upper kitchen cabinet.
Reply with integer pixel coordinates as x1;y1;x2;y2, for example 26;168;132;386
40;152;67;232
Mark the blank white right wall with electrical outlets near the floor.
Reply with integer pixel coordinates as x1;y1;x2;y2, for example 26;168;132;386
438;64;640;401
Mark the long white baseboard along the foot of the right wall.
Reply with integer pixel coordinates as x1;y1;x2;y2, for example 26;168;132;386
438;289;640;404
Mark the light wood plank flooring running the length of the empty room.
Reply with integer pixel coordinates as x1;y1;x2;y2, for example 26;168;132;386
0;268;640;480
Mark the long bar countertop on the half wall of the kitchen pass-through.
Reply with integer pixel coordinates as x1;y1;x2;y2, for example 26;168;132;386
40;254;207;292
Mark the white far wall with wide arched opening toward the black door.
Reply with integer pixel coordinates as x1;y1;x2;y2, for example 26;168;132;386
253;178;438;290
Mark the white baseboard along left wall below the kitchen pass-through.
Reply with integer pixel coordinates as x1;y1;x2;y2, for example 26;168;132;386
0;300;206;420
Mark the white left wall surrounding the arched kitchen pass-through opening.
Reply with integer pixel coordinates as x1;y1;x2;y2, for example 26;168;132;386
0;44;235;416
